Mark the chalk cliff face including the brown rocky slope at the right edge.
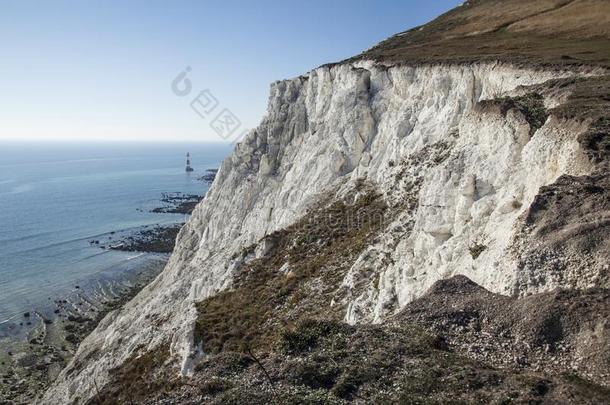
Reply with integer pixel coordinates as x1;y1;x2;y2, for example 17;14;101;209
42;2;610;403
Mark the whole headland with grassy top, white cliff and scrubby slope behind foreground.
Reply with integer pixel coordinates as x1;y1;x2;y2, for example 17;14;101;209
41;0;610;404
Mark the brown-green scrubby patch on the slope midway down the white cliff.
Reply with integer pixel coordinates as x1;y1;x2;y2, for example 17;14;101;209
195;188;386;353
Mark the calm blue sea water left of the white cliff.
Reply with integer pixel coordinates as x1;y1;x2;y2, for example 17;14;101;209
0;143;230;323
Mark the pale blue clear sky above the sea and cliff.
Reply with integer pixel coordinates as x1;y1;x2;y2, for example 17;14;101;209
0;0;462;142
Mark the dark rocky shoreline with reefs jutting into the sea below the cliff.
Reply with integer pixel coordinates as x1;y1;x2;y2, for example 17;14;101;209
0;189;203;404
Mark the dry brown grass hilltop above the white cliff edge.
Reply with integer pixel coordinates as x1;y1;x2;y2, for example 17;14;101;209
344;0;610;67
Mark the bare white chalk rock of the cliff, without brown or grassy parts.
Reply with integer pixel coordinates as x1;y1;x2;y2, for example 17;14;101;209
42;61;604;404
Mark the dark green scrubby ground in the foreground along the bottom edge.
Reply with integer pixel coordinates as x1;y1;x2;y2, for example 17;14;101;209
90;288;608;404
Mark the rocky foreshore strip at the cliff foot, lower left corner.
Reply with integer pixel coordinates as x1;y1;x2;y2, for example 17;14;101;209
0;253;169;404
